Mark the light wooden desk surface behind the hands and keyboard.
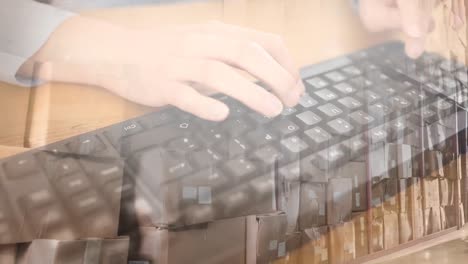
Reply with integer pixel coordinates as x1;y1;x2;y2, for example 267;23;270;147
0;0;466;150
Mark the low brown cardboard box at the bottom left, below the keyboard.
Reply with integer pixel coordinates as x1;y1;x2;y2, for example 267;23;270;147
16;237;129;264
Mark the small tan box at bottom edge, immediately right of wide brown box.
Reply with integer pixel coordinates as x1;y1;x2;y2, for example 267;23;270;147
299;226;330;264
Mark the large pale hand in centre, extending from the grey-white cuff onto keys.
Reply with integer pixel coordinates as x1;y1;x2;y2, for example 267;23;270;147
32;17;305;121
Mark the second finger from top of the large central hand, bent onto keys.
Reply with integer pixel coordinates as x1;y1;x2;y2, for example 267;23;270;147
179;35;305;106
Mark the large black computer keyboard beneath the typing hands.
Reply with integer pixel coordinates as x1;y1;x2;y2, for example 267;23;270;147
0;43;468;243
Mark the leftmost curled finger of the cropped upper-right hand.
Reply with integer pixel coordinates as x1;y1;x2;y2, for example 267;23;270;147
360;0;401;32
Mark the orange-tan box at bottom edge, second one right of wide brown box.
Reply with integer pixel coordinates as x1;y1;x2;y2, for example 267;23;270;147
329;222;356;264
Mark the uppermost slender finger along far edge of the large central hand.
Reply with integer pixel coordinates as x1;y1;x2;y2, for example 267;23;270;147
188;22;300;79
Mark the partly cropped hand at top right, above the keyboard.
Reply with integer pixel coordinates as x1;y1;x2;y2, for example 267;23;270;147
360;0;466;58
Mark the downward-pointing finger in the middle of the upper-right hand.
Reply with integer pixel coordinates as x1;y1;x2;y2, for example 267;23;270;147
397;0;436;38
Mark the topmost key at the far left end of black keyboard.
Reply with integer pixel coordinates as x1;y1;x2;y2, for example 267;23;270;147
4;155;40;180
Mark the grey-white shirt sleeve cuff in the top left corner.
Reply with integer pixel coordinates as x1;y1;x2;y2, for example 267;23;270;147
0;0;74;86
